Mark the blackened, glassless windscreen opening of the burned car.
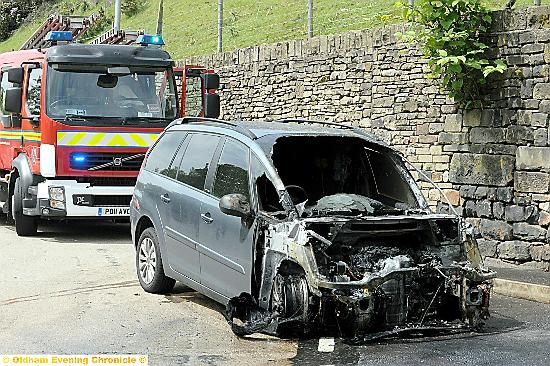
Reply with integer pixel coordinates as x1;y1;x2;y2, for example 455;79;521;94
270;135;419;214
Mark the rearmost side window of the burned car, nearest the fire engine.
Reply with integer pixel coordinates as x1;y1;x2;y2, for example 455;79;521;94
145;131;185;178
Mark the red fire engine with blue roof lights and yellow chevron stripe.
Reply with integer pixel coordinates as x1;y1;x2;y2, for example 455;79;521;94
0;32;219;236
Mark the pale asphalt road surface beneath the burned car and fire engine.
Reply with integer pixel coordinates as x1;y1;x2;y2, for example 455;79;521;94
0;220;550;366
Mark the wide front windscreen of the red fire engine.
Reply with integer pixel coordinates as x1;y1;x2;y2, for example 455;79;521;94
46;64;178;125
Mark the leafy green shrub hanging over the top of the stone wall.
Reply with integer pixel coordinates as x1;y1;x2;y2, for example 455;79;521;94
402;0;507;108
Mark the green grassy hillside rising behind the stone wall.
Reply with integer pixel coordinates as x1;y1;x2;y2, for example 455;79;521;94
0;0;548;59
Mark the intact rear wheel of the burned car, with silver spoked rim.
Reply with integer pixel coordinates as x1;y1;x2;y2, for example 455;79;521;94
136;227;176;294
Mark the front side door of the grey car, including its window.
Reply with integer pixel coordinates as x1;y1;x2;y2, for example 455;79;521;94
198;137;254;298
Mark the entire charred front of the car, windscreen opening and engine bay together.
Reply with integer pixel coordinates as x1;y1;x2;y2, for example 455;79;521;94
226;138;496;342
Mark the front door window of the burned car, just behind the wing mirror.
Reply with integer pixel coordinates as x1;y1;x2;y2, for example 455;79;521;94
212;138;250;200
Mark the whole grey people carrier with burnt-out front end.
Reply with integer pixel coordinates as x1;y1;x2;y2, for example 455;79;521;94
130;118;494;339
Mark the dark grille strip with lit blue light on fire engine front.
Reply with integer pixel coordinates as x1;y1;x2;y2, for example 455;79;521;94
69;152;145;171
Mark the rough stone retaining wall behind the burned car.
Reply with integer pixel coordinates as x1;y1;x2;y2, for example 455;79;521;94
180;7;550;269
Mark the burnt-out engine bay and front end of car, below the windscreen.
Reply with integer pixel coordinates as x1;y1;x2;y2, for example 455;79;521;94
228;215;495;341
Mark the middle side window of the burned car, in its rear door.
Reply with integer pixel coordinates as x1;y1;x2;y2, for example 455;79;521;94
176;134;220;189
